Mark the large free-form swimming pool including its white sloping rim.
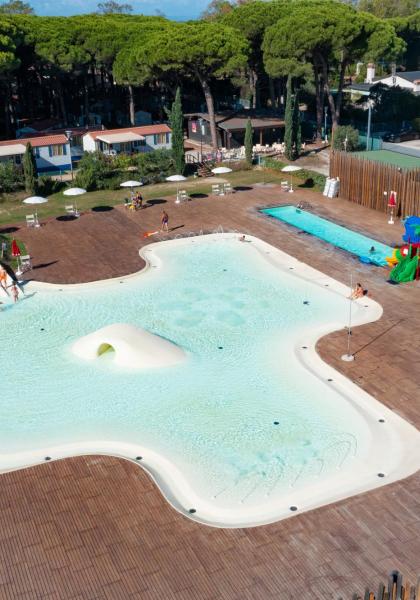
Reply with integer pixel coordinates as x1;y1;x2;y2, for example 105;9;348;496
0;234;420;527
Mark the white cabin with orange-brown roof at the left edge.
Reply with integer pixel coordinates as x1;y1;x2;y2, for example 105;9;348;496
0;134;71;173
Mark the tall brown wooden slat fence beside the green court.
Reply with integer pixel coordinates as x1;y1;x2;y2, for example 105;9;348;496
330;150;420;217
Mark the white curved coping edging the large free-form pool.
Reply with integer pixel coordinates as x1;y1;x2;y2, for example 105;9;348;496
0;233;420;527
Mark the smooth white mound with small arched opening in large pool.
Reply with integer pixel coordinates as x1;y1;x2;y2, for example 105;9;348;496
72;323;186;369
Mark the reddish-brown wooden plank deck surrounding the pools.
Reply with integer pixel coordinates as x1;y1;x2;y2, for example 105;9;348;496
0;187;420;600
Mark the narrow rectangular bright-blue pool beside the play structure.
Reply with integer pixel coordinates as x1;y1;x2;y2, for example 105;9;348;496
261;206;393;266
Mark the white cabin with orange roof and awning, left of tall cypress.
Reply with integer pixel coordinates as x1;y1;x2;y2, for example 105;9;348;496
83;125;172;154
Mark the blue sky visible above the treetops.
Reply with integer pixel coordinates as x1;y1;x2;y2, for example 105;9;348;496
26;0;208;20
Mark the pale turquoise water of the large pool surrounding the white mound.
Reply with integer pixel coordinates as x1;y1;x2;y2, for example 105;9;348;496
0;237;380;514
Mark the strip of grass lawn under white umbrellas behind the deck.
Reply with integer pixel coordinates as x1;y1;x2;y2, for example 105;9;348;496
0;169;320;225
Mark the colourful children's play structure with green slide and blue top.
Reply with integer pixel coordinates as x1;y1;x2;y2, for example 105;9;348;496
386;217;420;283
